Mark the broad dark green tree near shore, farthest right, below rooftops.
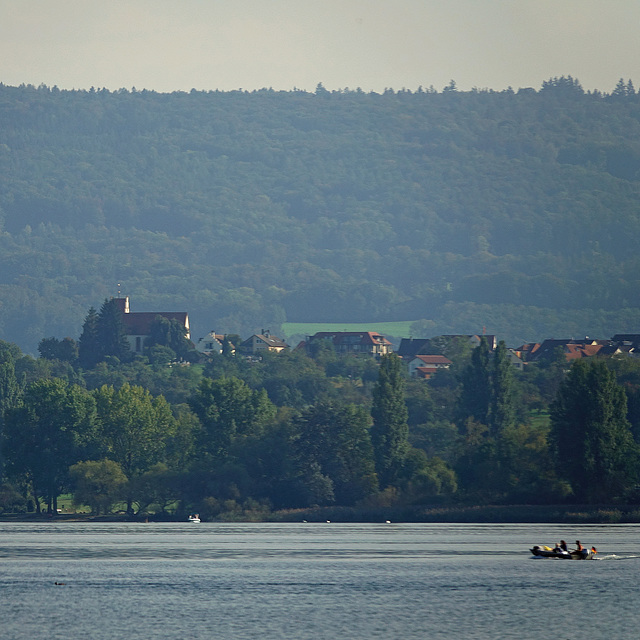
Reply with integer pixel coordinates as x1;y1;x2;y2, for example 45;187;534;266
551;359;638;502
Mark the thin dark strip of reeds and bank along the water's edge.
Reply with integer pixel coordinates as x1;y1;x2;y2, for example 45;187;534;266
5;505;640;525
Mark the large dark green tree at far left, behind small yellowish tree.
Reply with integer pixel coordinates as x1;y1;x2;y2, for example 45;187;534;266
5;378;96;513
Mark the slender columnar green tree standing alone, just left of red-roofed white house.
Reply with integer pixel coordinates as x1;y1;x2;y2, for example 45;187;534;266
371;354;409;489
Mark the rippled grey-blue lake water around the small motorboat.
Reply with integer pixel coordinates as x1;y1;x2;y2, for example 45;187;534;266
0;522;640;640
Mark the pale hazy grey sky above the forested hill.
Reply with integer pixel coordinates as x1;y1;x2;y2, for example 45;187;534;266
0;0;640;91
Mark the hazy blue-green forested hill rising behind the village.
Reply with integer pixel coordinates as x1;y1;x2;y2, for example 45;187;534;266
0;78;640;352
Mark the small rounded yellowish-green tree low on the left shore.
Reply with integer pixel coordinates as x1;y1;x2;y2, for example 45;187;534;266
69;459;127;515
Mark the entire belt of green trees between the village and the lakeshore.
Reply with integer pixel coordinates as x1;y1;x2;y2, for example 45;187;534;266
0;318;640;517
